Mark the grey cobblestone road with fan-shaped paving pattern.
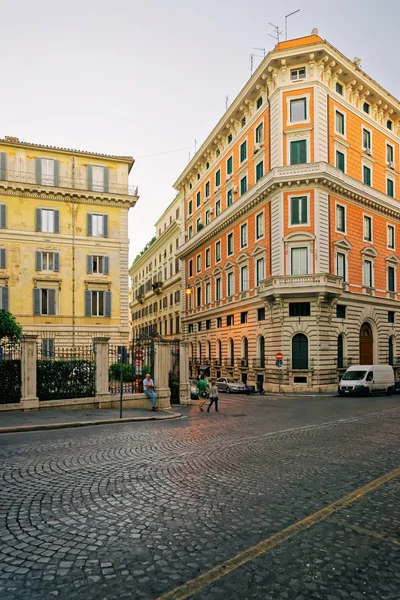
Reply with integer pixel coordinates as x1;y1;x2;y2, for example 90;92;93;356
0;395;400;600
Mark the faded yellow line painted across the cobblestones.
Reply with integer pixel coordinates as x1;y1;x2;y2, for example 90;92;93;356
157;467;400;600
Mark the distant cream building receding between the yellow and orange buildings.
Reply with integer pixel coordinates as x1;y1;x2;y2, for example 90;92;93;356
129;195;182;339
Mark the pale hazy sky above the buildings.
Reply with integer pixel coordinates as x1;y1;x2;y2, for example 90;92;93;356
0;0;400;260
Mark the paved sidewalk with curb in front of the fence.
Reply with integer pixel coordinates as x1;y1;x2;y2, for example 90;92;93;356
0;408;182;434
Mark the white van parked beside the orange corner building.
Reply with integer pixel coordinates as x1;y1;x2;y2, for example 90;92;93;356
338;365;394;396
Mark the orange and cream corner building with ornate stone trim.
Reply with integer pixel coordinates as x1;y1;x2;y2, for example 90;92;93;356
175;30;400;390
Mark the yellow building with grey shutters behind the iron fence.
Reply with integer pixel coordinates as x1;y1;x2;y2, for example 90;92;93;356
0;137;138;351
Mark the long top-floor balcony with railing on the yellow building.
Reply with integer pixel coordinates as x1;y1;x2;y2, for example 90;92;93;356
0;169;139;197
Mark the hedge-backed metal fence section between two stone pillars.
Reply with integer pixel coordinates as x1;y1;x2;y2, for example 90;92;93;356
36;344;96;400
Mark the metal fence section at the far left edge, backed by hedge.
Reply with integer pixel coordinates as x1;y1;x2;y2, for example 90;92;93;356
0;344;21;404
